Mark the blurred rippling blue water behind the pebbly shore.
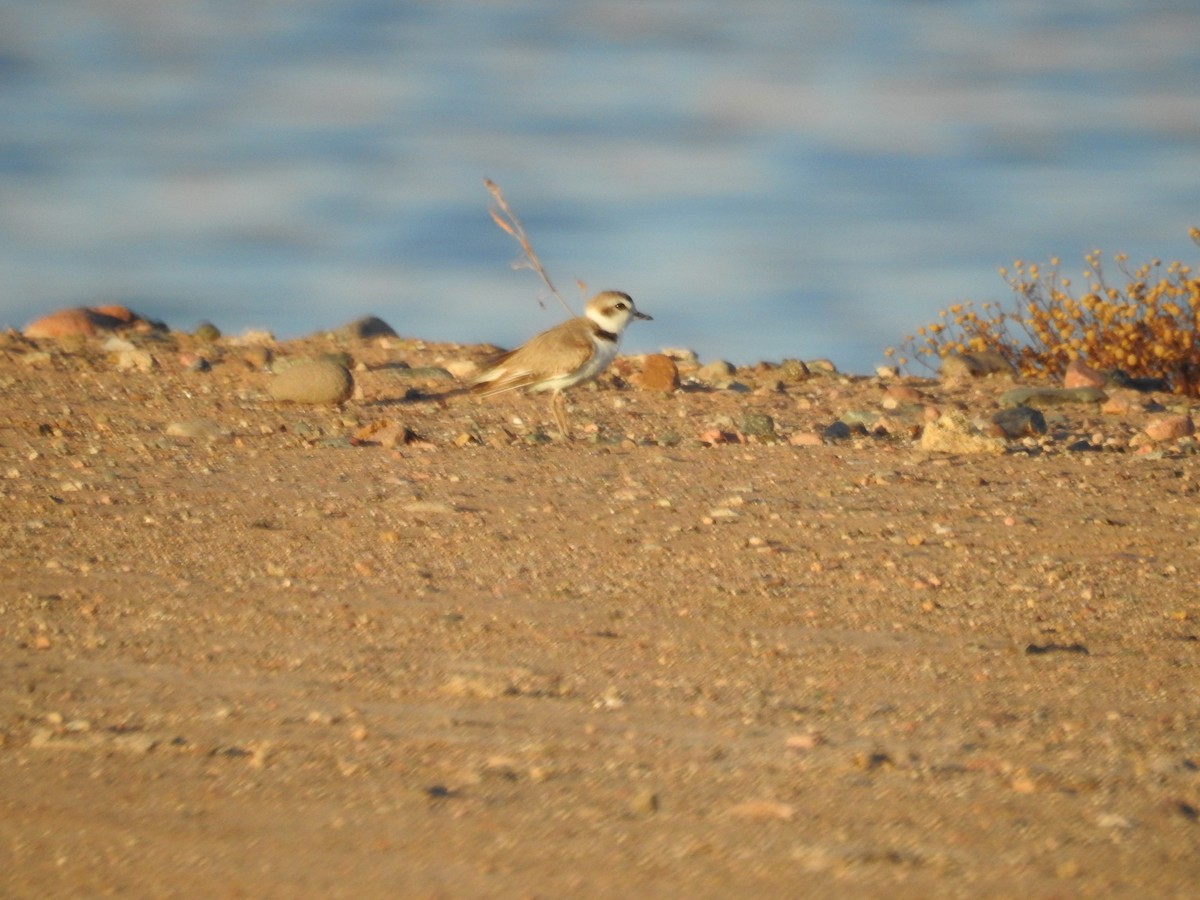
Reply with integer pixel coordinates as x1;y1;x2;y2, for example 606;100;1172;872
0;0;1200;372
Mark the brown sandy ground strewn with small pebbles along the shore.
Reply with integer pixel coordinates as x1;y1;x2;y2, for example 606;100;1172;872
0;326;1200;898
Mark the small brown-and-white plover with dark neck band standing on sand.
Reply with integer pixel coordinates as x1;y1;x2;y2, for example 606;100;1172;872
470;290;650;439
